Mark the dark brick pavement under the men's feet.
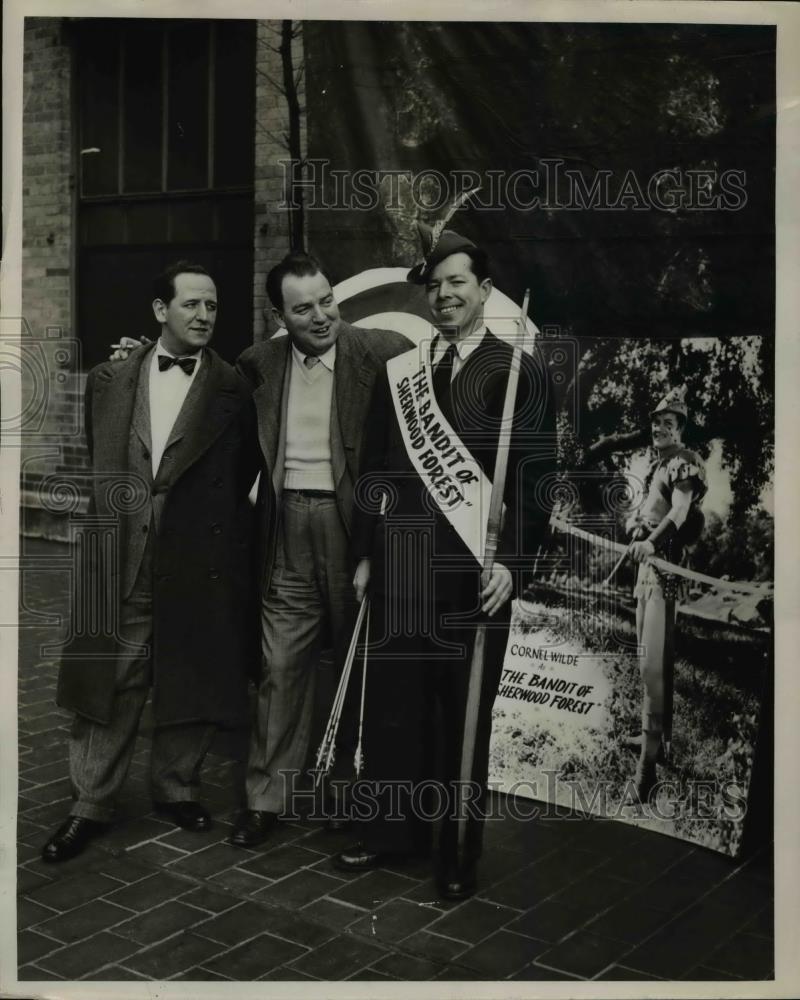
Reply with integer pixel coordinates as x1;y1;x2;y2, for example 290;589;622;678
17;543;773;981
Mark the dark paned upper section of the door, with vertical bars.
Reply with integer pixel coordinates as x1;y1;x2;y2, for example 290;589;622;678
77;19;255;199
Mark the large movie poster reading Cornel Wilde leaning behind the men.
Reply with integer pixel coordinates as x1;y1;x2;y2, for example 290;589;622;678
490;337;773;855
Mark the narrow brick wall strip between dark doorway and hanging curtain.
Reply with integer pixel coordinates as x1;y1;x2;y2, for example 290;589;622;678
253;21;306;341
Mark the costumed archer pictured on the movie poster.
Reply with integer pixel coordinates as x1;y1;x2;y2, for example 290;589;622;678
628;389;706;804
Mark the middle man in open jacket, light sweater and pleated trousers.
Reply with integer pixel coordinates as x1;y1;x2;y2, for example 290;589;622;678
231;253;411;847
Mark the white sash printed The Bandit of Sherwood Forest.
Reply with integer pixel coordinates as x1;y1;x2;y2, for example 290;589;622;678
386;347;492;566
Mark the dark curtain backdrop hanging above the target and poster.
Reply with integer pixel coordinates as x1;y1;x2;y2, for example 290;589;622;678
305;22;775;338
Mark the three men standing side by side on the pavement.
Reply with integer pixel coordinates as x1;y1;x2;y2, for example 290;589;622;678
44;238;554;898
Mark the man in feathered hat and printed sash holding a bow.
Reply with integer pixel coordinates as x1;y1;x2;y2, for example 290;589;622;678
336;211;555;899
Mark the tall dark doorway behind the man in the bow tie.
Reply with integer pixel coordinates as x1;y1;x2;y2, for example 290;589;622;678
75;19;256;367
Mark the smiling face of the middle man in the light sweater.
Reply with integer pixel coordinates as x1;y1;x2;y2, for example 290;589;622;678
273;271;341;356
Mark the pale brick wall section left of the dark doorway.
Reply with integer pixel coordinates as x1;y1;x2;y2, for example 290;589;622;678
21;18;87;537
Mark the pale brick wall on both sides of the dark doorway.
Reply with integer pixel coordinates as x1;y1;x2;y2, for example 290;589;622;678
21;18;306;538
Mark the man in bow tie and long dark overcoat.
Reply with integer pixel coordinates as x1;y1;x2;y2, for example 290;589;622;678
42;262;258;862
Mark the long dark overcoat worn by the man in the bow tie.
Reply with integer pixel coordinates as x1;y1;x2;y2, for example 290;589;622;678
57;344;260;726
